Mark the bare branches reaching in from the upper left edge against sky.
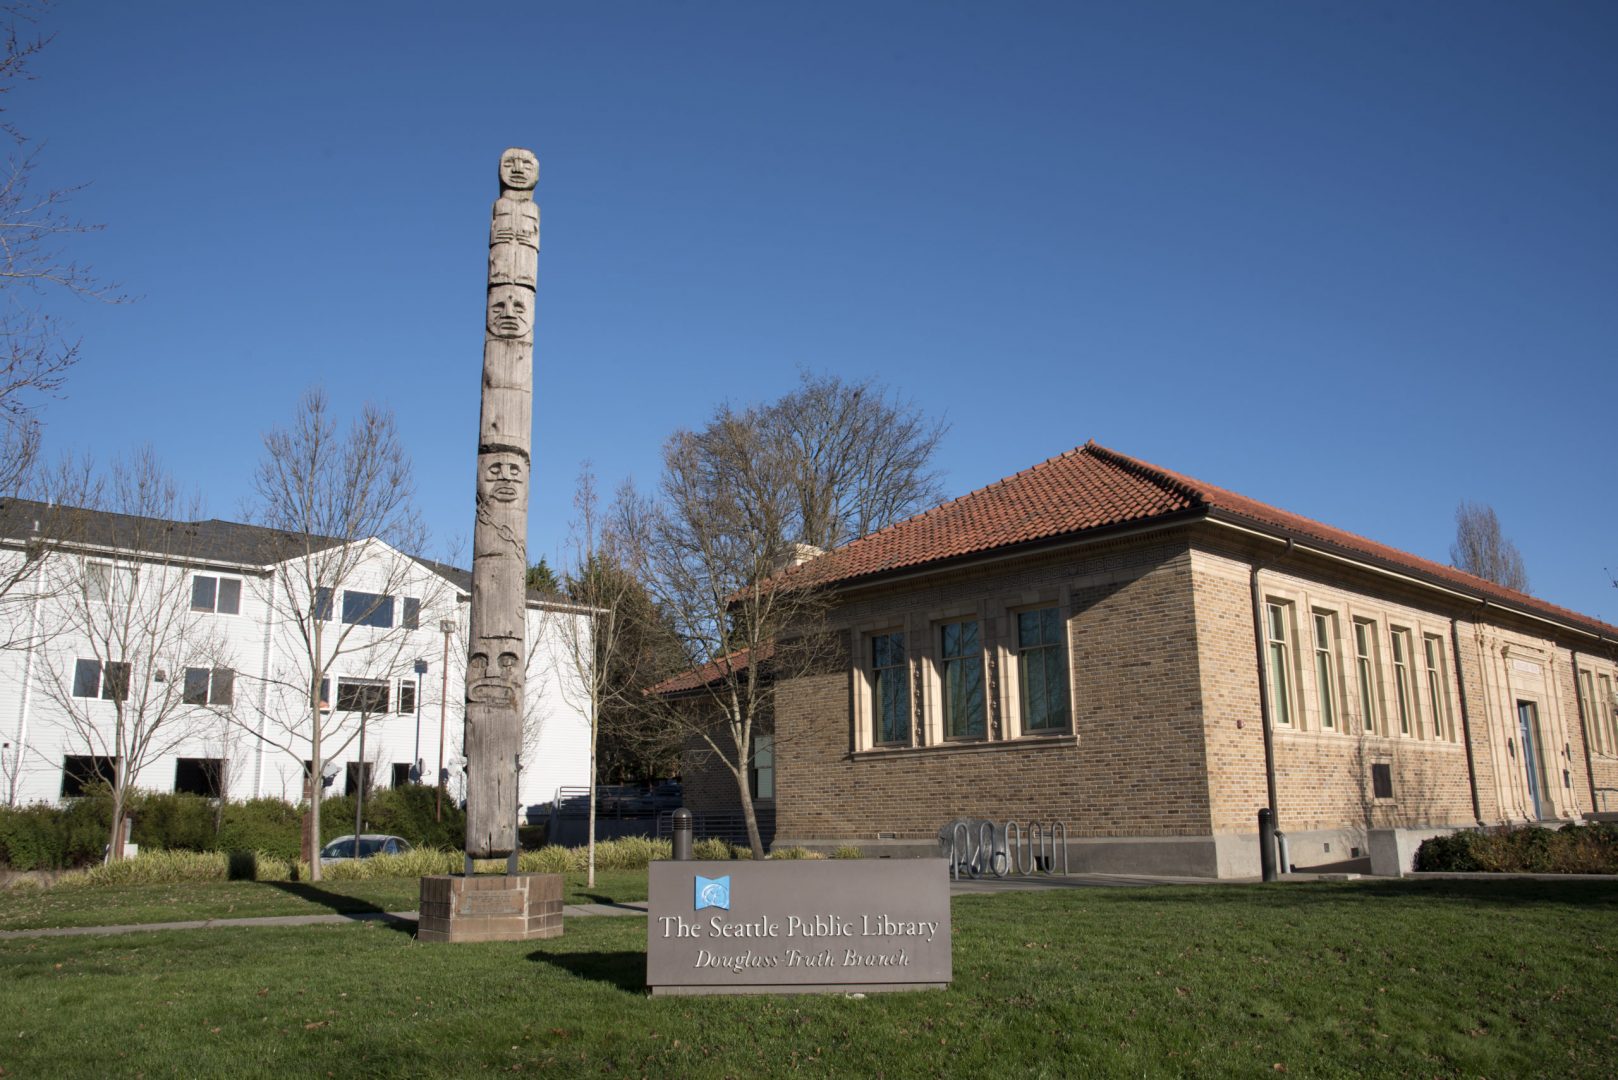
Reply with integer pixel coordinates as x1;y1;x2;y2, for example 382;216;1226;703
0;3;123;495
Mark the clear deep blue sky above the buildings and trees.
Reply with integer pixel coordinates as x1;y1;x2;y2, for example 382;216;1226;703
6;0;1618;622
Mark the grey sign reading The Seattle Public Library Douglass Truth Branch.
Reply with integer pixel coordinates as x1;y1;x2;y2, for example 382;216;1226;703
646;858;951;994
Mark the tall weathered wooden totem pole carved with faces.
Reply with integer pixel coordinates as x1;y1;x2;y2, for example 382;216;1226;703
466;149;539;860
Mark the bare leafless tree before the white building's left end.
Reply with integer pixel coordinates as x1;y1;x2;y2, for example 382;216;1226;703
39;450;236;858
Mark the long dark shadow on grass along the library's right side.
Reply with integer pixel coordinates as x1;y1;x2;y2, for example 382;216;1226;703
1092;878;1618;908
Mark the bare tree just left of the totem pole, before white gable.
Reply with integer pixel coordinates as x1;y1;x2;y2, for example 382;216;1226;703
236;389;450;881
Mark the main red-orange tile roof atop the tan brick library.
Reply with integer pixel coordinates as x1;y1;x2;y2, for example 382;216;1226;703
786;440;1618;636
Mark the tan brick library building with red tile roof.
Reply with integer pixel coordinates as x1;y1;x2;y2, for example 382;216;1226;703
686;442;1618;878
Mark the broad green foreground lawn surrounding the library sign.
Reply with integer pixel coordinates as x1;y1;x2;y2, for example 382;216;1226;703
0;881;1618;1078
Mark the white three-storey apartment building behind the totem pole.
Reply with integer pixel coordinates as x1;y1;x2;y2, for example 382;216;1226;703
0;500;591;810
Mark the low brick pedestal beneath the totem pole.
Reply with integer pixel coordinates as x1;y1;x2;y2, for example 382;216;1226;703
416;874;561;941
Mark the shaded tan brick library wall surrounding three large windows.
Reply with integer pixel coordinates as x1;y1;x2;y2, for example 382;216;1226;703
775;544;1209;839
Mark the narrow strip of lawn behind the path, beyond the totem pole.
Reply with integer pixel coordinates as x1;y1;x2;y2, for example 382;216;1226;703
0;870;646;929
